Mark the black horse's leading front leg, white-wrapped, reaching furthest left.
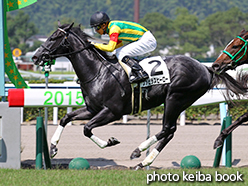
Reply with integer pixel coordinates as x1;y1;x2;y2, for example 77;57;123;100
50;107;94;158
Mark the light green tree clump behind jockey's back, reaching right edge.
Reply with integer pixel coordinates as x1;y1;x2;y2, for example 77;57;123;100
140;8;248;60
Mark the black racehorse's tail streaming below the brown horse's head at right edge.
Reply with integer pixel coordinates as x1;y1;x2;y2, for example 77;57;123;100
211;68;248;103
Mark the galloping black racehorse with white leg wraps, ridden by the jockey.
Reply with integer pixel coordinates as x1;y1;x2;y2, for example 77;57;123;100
32;24;246;169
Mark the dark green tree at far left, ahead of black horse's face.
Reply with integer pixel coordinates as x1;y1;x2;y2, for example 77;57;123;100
7;11;40;53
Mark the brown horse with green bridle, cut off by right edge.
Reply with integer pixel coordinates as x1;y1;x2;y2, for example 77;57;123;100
212;30;248;149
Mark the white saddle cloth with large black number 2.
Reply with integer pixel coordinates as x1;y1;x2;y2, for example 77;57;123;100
119;56;170;88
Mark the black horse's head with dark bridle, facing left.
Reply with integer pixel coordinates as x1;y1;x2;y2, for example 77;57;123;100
32;23;73;66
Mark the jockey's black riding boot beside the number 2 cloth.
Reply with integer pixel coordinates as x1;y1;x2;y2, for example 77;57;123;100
122;56;149;83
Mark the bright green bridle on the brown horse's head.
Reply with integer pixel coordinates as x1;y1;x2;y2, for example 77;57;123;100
220;36;248;73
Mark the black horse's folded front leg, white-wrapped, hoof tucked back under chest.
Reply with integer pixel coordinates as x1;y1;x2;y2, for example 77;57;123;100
83;107;120;148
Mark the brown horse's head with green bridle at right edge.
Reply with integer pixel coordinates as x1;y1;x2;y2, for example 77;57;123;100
212;30;248;73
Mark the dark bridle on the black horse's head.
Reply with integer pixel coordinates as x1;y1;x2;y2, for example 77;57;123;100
41;28;90;62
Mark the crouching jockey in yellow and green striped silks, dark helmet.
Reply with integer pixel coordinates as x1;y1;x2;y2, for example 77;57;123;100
90;12;157;83
